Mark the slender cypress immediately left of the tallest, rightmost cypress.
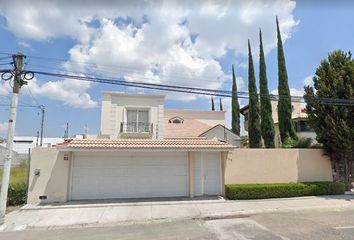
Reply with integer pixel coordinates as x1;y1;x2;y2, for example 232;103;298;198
259;30;275;148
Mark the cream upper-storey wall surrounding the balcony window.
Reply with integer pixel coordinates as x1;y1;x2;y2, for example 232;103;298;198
101;92;164;138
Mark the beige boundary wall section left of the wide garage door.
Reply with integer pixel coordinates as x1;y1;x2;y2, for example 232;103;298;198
27;148;70;204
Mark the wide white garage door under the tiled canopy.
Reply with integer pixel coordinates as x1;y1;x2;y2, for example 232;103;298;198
71;153;187;200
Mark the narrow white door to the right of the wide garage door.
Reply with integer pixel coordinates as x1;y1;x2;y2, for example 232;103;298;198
194;152;222;196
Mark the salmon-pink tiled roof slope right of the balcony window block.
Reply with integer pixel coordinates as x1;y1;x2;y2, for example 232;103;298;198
164;119;213;137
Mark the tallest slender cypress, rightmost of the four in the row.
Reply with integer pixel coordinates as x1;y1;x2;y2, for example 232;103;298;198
276;17;297;142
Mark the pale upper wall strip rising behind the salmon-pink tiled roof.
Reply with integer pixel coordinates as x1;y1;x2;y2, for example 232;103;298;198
165;109;225;126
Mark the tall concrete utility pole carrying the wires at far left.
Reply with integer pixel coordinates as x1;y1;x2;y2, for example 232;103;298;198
0;53;27;225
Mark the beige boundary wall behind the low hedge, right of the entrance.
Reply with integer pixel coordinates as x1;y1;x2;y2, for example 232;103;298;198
225;149;333;184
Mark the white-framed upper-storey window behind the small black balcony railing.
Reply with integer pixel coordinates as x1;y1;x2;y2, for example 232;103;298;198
127;110;149;132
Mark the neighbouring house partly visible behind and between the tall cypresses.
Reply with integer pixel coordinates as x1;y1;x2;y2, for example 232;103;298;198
240;99;317;147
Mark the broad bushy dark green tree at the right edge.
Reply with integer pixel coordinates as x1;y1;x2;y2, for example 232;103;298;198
304;50;354;188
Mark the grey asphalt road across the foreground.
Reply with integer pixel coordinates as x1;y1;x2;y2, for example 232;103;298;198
0;209;354;240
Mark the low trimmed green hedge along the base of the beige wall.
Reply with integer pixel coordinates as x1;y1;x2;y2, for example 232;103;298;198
225;182;345;199
